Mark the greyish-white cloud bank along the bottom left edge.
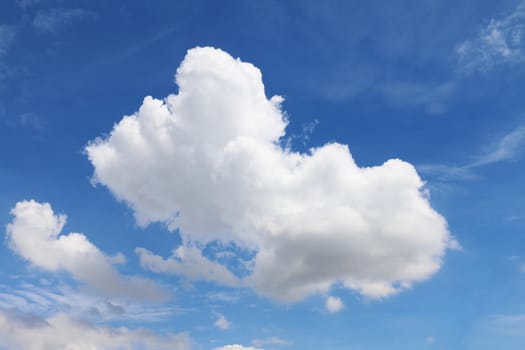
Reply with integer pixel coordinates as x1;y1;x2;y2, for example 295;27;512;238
0;311;191;350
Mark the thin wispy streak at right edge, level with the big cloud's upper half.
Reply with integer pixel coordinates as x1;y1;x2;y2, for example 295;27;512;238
417;126;525;181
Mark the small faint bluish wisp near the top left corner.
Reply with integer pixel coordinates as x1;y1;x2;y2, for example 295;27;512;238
32;8;97;34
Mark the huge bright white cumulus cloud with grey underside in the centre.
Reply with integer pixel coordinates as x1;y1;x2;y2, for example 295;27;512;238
86;47;455;301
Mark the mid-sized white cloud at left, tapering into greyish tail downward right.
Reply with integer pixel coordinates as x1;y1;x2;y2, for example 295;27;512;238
6;200;166;300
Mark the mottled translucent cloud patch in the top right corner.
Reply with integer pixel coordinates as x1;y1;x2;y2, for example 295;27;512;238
456;2;525;73
